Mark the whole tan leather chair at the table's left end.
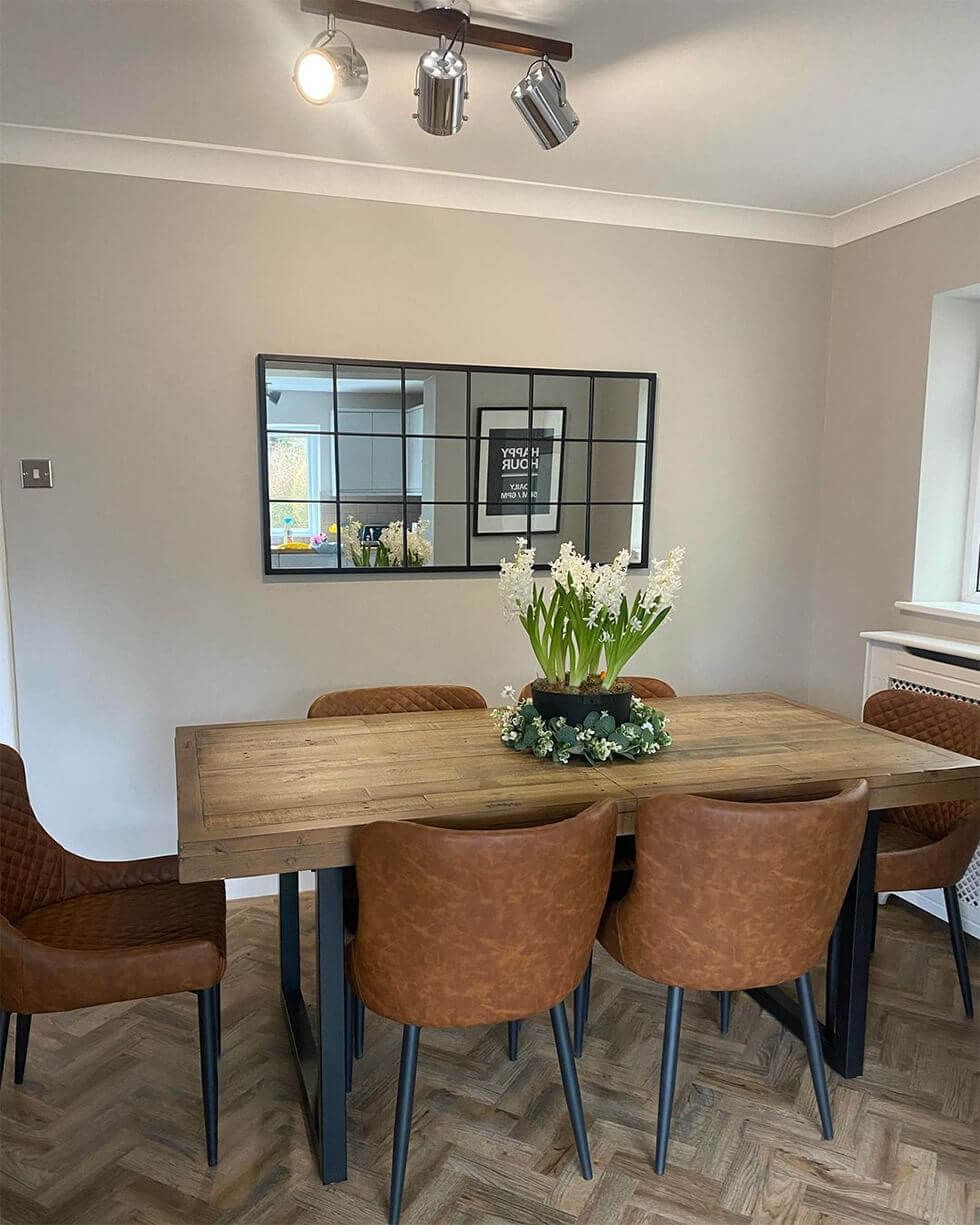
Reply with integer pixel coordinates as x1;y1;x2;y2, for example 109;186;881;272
0;745;225;1165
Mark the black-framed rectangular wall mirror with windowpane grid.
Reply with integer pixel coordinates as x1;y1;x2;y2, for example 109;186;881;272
257;355;655;576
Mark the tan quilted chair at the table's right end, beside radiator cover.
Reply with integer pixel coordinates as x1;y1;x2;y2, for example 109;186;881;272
864;690;980;1017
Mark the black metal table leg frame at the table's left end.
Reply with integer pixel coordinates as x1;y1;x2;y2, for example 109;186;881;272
279;867;347;1182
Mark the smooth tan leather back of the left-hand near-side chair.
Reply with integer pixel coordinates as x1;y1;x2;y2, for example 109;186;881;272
350;800;617;1027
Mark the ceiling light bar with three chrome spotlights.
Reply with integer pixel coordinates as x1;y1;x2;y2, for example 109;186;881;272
293;0;578;149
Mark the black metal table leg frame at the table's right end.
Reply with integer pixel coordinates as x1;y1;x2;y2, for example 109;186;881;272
748;812;880;1078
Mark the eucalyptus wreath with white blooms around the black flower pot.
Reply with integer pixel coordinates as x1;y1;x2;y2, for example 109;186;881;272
491;698;670;766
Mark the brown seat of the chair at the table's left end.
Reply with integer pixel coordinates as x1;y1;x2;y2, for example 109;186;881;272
11;881;225;1012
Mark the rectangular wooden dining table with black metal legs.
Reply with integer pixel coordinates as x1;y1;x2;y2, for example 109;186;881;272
175;693;980;1182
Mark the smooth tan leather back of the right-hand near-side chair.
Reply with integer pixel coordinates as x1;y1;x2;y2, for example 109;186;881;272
603;782;867;991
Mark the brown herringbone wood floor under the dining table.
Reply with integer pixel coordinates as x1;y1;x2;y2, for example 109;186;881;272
2;899;980;1225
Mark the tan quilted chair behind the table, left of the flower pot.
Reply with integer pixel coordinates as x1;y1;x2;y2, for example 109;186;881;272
306;685;487;1068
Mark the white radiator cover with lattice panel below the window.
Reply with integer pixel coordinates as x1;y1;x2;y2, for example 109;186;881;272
861;630;980;940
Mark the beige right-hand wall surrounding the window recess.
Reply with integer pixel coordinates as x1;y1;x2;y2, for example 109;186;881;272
810;200;980;714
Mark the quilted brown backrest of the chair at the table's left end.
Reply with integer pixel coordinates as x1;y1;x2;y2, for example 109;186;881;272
0;745;65;924
